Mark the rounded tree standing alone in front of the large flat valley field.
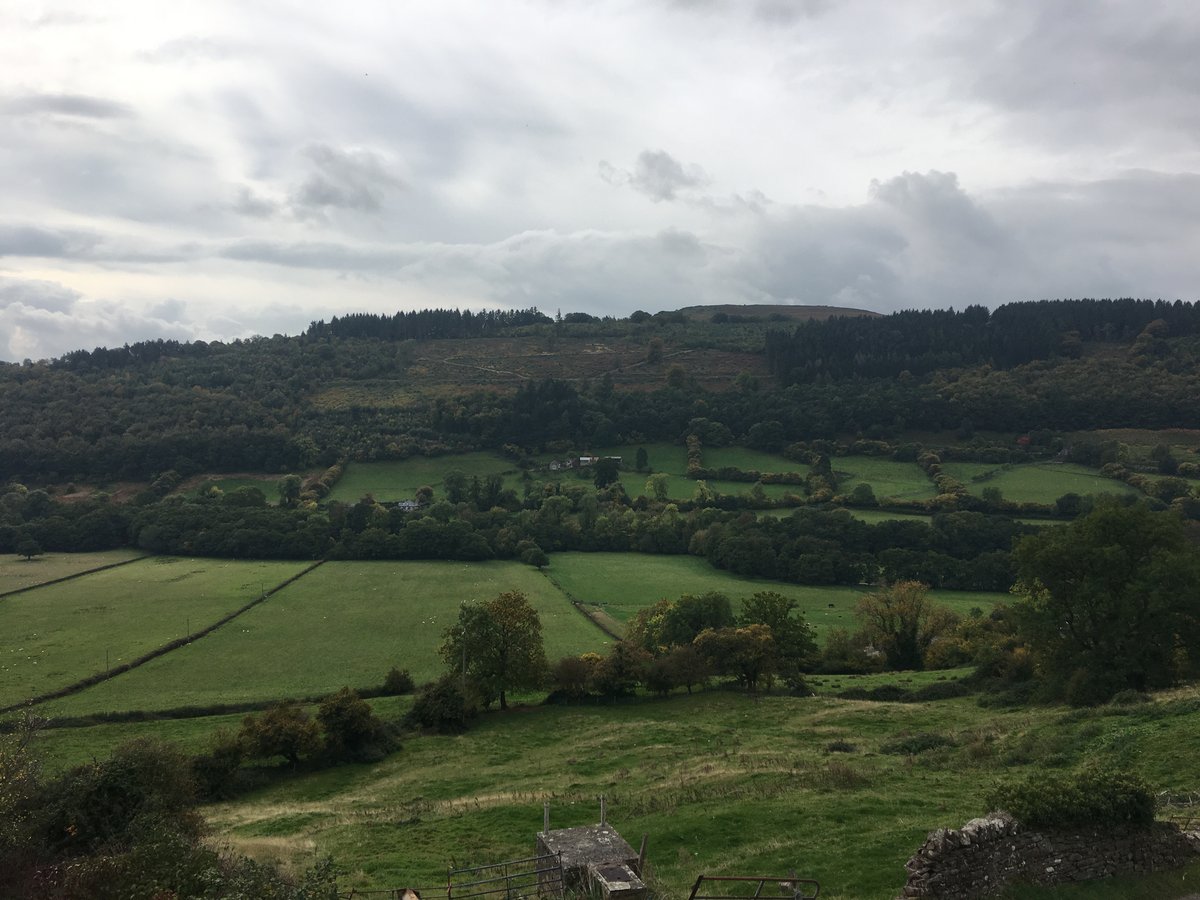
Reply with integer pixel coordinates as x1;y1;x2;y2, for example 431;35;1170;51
440;590;547;709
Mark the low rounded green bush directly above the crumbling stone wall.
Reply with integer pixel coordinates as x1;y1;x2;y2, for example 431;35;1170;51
988;768;1154;828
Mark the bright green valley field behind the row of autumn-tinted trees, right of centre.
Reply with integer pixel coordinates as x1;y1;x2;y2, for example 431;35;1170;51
546;552;1007;641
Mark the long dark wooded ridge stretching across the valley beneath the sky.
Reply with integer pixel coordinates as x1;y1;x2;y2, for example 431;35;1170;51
0;300;1200;481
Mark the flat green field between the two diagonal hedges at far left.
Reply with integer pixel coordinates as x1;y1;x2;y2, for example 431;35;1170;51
0;557;304;706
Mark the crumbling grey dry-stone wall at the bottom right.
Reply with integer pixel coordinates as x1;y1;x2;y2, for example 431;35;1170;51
900;812;1200;900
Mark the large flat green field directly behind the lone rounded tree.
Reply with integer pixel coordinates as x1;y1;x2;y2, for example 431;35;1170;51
47;562;607;715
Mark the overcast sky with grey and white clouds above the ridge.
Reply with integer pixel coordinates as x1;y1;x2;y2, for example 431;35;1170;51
0;0;1200;361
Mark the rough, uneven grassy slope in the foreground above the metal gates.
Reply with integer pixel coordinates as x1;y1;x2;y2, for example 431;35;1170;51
192;688;1200;900
